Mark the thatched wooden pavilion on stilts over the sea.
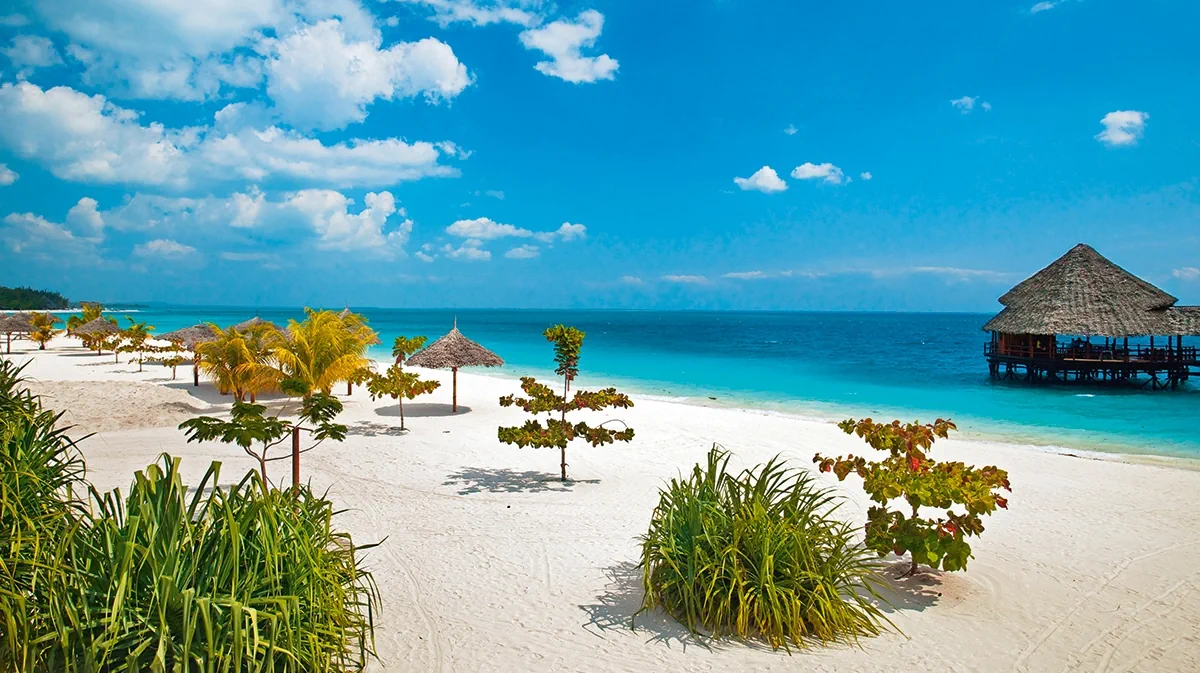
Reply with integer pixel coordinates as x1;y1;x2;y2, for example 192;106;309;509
983;244;1200;390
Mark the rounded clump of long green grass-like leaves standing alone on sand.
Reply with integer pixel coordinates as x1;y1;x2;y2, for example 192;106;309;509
638;445;888;651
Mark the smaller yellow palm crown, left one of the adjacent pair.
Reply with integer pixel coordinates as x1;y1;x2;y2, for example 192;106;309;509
196;325;278;402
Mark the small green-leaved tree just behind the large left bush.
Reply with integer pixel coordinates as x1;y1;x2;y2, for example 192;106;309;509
179;392;346;488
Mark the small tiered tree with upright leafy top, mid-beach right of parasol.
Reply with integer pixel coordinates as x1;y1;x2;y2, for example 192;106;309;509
498;325;634;481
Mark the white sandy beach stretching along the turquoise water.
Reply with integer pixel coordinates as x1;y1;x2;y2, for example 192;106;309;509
2;338;1200;673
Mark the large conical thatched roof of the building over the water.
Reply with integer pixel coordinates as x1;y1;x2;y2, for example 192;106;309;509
983;244;1200;337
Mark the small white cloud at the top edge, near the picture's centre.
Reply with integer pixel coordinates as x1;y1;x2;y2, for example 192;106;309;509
521;10;619;84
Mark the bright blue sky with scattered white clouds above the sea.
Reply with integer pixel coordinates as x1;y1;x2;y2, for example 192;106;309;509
0;0;1200;312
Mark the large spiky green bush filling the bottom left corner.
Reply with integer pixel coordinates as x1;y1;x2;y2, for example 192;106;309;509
0;363;378;673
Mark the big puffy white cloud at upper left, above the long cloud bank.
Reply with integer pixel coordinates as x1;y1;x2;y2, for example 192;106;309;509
266;20;472;131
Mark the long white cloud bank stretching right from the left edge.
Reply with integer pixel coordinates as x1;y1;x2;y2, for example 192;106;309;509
0;82;458;188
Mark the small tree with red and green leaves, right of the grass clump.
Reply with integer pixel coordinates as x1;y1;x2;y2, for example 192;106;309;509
812;419;1012;576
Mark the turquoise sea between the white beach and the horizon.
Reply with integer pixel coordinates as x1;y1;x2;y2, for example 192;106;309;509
96;307;1200;458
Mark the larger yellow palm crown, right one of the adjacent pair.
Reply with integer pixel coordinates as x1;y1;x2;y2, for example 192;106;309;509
274;308;373;397
